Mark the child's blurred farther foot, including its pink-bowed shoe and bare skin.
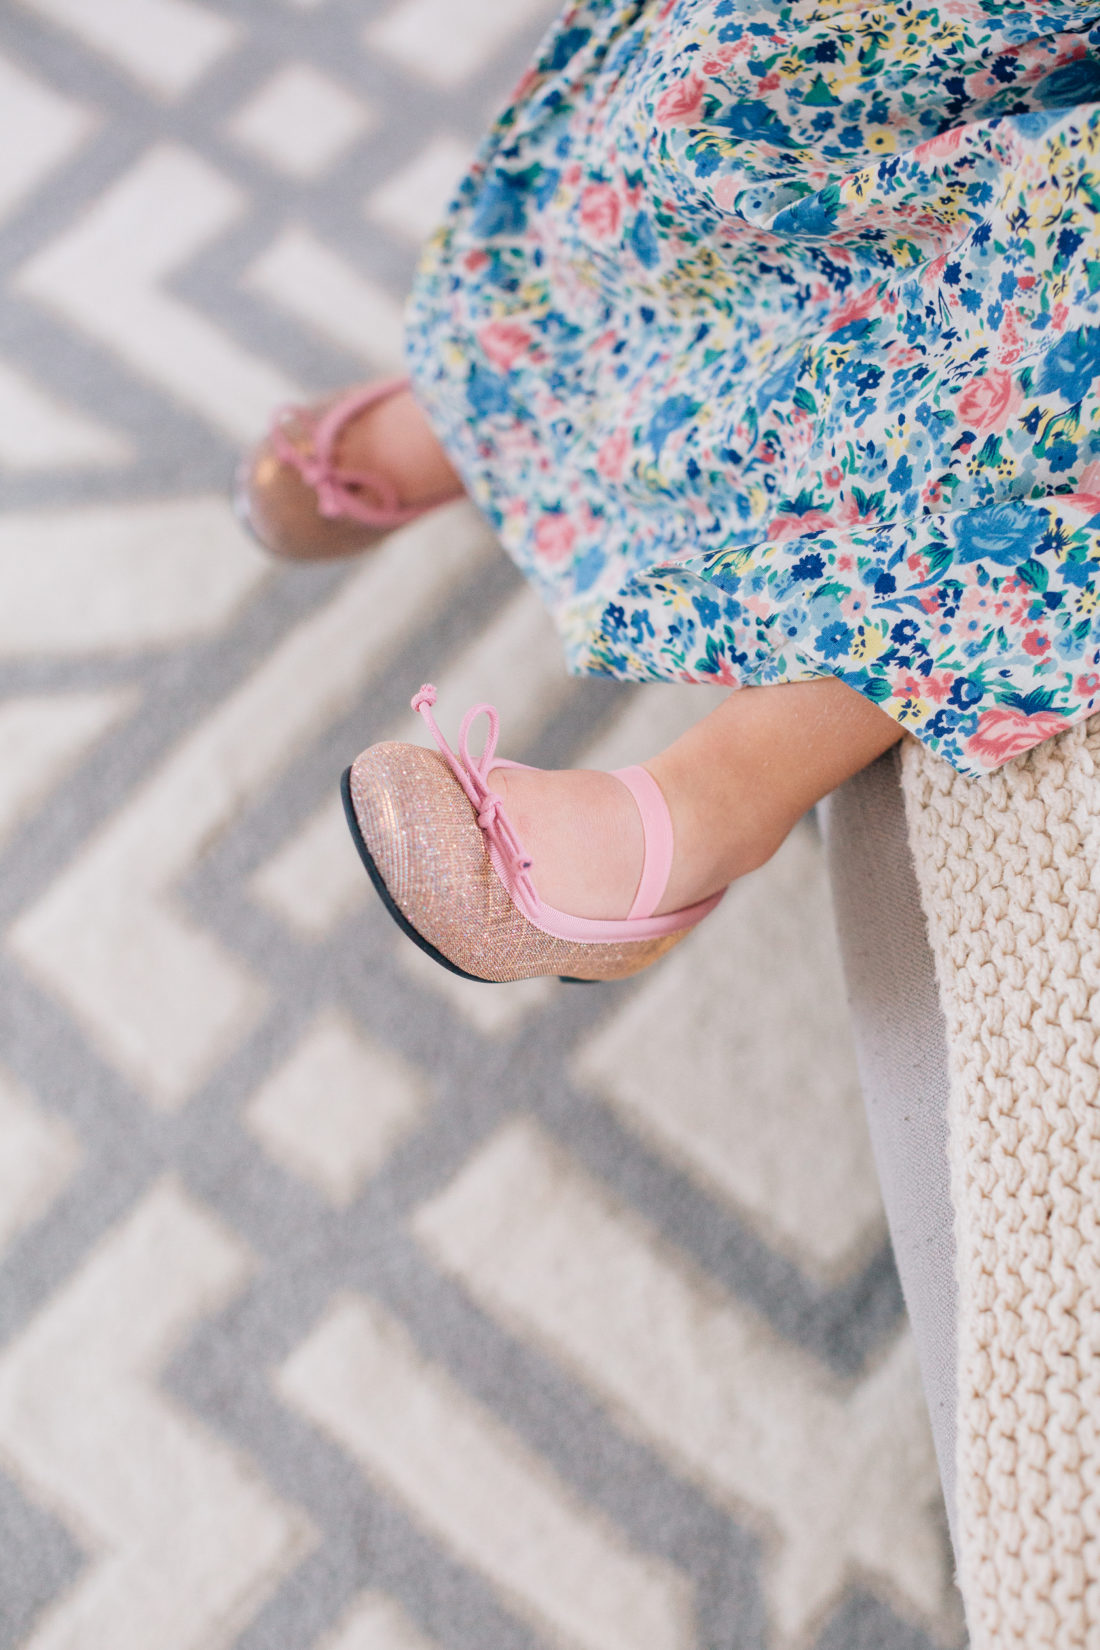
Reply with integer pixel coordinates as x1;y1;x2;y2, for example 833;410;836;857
237;380;462;559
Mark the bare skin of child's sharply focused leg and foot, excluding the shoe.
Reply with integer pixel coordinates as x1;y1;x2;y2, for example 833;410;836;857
491;677;902;917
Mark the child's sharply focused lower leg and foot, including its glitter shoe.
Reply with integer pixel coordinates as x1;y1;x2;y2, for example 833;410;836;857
345;678;900;980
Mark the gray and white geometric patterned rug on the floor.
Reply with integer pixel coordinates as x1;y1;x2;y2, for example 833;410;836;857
0;0;961;1650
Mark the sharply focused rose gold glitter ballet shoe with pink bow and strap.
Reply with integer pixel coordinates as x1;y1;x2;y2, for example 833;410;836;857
343;683;722;982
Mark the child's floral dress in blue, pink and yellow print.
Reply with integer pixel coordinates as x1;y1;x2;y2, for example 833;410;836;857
407;0;1100;774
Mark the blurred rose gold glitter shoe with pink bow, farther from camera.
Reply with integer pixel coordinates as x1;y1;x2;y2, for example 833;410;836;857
233;378;458;561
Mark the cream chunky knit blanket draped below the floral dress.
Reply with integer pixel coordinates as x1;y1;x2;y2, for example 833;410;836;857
902;718;1100;1650
